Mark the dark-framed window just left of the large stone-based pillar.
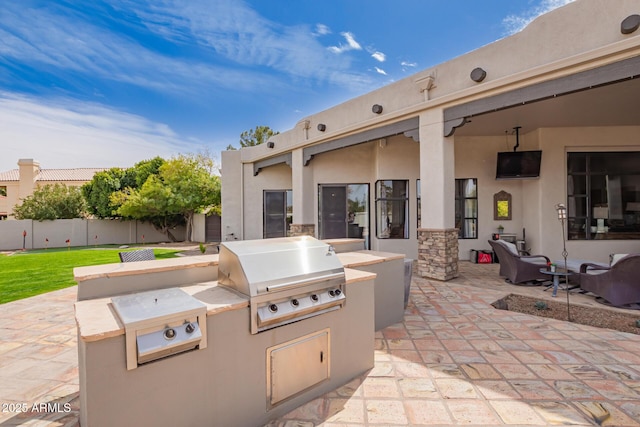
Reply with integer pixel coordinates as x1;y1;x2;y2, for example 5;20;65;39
376;180;409;239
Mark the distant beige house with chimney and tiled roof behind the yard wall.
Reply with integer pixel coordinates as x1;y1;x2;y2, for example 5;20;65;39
0;159;106;219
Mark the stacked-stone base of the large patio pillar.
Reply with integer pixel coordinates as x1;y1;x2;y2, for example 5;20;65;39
418;228;458;280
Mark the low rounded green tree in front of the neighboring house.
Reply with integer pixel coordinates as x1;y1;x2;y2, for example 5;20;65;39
13;184;86;221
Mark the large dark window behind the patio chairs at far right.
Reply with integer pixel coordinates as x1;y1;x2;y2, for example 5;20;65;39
567;151;640;240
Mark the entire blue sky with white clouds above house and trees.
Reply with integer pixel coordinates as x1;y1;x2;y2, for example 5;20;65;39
0;0;570;171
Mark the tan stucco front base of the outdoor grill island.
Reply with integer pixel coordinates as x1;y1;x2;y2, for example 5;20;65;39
77;272;375;427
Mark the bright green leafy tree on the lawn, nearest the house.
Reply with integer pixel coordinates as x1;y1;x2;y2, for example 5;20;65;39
112;154;221;241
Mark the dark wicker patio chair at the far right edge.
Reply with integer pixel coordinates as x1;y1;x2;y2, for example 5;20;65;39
580;254;640;309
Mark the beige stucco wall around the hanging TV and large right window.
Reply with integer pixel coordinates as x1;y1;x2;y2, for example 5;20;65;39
455;126;640;262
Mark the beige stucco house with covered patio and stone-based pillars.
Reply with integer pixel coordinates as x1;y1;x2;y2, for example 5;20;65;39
222;0;640;280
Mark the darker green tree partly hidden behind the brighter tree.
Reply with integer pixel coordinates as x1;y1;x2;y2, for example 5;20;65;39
82;157;164;218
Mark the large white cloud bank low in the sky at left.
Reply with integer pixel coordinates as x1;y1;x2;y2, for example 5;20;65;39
0;92;204;171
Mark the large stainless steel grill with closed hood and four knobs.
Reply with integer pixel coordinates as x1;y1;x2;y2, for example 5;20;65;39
218;236;346;334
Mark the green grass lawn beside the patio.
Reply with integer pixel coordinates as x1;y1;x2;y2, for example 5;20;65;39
0;247;180;304
